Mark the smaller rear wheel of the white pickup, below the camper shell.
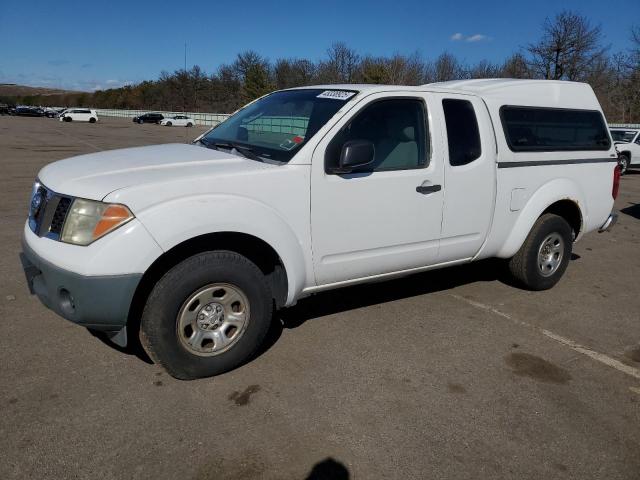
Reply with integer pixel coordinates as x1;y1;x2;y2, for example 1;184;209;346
509;213;573;291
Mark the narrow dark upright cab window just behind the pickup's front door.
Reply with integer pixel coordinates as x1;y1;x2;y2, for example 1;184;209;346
442;98;482;167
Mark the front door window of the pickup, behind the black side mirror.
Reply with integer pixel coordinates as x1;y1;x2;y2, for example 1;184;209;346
325;98;428;173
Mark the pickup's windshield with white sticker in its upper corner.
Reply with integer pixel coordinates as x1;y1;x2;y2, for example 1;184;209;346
201;89;357;162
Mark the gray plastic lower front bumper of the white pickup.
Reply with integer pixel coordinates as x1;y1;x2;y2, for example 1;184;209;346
20;242;142;344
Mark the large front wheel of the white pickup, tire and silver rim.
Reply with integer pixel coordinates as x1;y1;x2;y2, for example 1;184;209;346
140;250;273;380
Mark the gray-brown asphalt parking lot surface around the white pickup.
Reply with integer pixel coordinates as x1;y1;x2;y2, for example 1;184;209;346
0;117;640;480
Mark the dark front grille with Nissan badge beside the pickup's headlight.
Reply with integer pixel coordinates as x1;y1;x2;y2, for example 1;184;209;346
29;183;73;240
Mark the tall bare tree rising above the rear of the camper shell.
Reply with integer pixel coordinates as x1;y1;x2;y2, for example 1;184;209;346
527;10;606;80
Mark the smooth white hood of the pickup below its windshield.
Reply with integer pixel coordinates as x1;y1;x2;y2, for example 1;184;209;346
38;143;278;200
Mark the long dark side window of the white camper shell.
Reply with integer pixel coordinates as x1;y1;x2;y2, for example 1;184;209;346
500;106;611;152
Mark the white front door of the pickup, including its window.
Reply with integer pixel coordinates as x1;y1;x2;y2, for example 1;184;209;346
311;92;444;285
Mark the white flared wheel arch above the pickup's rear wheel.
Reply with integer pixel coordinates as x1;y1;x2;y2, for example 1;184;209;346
497;178;587;258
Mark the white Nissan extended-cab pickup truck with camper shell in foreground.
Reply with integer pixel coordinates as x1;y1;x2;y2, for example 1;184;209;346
21;80;619;379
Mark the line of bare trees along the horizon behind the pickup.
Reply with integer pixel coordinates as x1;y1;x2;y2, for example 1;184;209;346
7;11;640;123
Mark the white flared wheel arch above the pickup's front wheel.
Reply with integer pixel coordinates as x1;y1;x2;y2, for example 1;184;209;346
137;194;307;305
